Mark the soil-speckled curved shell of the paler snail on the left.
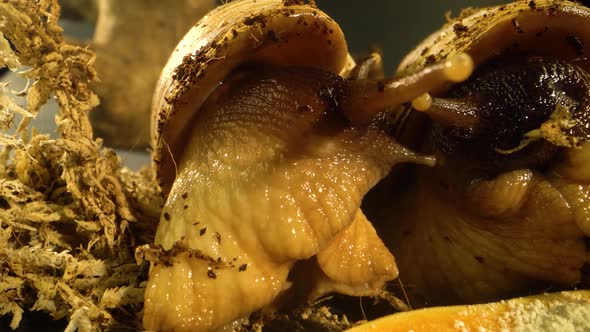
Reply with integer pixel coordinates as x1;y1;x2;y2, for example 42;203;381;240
151;0;354;195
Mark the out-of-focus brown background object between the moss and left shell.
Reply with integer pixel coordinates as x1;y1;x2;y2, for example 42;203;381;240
60;0;215;148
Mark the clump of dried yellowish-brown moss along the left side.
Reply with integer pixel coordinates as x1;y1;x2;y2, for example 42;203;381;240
0;0;161;331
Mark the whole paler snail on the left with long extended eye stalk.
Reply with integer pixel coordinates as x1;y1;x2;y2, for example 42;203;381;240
139;0;472;331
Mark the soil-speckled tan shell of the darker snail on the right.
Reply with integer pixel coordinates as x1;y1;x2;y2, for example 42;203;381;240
398;0;589;75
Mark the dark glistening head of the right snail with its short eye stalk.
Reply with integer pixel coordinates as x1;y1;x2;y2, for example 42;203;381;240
420;56;590;175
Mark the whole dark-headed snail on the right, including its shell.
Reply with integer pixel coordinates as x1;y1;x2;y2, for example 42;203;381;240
372;1;590;306
